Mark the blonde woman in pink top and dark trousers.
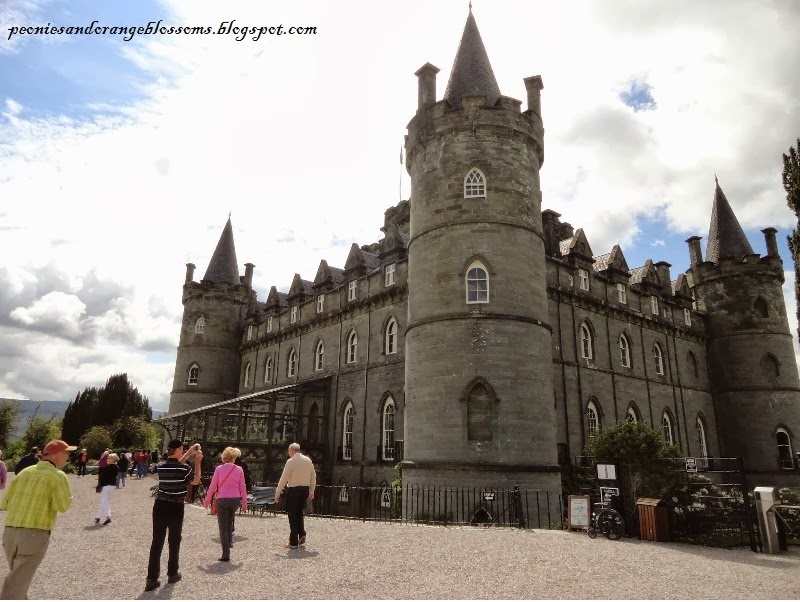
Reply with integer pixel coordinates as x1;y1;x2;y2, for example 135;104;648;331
203;447;247;562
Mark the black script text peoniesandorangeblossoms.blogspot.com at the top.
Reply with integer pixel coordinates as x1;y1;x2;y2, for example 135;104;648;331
8;19;317;42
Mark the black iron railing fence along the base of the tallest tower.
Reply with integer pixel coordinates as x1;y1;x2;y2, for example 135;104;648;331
250;484;563;529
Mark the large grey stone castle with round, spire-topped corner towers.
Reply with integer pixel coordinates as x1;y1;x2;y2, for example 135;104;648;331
166;11;800;491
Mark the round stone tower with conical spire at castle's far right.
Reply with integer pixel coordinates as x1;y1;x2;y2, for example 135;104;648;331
687;182;800;473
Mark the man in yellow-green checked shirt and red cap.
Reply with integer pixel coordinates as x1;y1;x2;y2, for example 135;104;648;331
0;440;77;600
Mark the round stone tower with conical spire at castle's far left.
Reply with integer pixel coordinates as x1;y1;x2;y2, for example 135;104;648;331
169;218;255;414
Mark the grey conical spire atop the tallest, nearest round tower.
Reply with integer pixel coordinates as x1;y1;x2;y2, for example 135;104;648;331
444;6;500;107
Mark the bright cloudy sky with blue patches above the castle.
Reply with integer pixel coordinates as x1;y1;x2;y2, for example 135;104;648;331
0;0;800;409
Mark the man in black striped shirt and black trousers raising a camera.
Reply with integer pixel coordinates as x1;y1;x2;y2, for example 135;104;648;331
144;439;203;592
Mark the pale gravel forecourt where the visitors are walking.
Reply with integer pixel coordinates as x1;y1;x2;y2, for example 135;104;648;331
0;476;800;600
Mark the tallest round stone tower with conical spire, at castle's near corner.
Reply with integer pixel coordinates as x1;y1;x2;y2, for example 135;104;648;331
403;10;561;491
